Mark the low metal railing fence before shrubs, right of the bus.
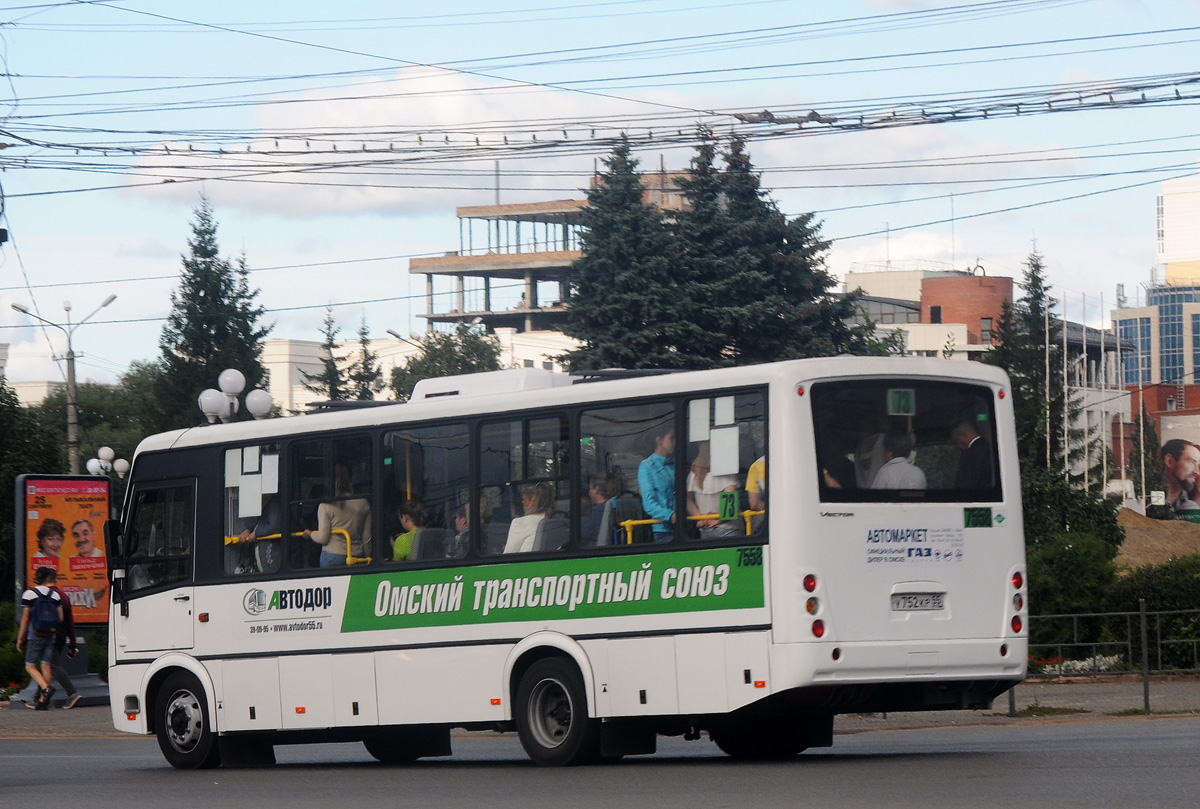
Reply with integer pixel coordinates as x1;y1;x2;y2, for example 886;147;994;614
1030;603;1200;677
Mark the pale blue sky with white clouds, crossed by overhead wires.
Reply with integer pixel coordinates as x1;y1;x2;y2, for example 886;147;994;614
0;0;1200;383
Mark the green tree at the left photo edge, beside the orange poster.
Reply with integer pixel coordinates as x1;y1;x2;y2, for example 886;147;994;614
0;377;60;603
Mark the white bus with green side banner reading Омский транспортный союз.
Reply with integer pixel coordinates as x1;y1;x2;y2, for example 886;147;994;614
106;358;1027;768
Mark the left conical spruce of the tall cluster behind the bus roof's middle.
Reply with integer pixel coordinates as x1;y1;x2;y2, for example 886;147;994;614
563;138;714;370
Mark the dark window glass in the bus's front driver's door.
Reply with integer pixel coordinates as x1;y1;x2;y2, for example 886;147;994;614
125;483;196;595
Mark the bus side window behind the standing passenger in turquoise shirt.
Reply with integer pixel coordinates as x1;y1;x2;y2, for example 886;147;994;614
577;402;674;547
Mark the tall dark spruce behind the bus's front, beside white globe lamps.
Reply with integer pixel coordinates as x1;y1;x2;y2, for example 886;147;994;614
147;197;270;432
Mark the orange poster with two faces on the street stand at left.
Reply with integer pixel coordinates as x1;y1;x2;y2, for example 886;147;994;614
16;475;109;624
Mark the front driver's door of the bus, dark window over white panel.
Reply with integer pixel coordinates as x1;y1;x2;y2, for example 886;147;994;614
113;480;196;657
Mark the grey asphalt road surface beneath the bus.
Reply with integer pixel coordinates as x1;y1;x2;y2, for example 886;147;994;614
0;712;1200;809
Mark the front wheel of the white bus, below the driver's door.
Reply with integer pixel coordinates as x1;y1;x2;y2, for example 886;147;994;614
155;671;221;769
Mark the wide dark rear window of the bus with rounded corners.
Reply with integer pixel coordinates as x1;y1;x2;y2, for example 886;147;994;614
811;379;1001;503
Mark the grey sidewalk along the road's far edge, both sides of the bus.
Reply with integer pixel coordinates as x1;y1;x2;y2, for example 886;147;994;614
0;676;1200;738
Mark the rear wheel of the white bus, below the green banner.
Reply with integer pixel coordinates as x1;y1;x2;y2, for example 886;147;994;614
514;658;600;767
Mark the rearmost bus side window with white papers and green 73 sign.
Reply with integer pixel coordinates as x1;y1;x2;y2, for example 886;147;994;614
685;392;767;541
